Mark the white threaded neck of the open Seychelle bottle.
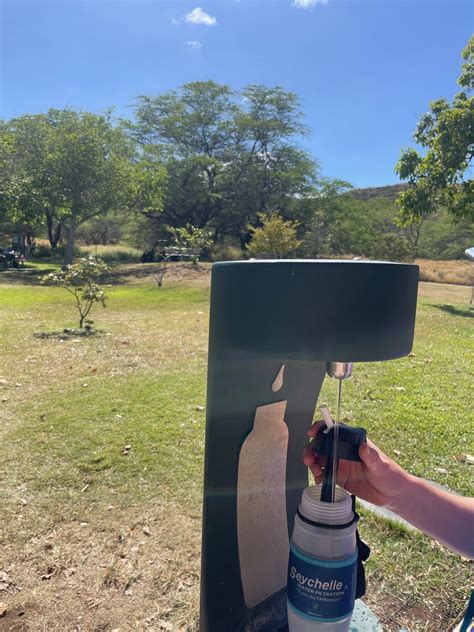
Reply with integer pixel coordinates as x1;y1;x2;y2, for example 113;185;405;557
299;485;354;525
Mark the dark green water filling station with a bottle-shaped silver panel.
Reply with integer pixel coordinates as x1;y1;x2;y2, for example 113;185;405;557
200;260;418;632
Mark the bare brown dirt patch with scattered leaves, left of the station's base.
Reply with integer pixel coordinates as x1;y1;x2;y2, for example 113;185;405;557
0;499;201;632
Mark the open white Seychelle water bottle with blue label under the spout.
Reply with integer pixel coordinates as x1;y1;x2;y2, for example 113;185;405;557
287;485;357;632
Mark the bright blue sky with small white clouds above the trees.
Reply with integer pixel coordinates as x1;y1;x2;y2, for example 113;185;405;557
0;0;473;187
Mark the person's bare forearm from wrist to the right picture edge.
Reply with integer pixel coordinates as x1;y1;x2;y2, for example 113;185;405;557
391;472;474;559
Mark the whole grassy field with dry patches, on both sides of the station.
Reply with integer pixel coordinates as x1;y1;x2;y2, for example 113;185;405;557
0;266;474;632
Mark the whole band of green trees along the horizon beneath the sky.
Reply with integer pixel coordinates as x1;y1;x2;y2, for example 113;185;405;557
0;73;474;263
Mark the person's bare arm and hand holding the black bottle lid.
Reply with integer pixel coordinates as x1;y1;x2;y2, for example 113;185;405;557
304;422;474;559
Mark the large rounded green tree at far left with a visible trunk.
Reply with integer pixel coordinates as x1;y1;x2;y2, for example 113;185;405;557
2;109;164;264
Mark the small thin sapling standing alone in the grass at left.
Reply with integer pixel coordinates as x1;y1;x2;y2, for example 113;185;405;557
42;257;109;329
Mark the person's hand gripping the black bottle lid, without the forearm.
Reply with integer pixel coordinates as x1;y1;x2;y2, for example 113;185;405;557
304;421;408;508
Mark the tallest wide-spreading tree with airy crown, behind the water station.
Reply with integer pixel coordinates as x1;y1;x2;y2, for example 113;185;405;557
130;81;317;239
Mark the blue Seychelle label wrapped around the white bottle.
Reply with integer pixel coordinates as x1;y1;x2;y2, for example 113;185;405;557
287;544;357;622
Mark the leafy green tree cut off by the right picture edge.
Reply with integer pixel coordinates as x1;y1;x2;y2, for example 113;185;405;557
395;36;474;224
